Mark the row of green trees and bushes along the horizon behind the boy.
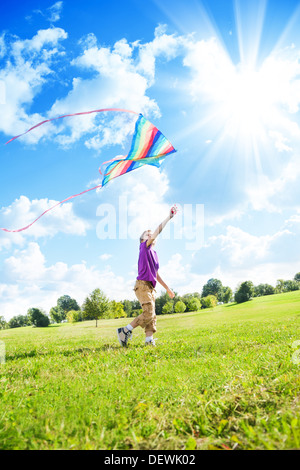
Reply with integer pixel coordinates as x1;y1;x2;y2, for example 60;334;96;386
0;272;300;329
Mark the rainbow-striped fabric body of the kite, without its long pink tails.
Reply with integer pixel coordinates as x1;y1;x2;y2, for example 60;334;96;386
102;114;176;186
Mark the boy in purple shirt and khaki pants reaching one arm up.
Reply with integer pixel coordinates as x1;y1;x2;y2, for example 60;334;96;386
117;207;176;346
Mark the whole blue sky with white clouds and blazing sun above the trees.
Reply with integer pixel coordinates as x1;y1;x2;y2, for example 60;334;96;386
0;0;300;319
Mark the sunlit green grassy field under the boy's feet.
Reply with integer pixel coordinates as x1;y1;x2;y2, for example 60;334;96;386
0;291;300;450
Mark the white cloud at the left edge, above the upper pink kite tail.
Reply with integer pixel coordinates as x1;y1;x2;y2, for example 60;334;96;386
0;28;67;142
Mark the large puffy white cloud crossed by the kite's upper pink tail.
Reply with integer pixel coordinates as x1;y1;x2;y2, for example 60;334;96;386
43;27;181;150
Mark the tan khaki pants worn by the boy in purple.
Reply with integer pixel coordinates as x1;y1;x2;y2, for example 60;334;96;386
133;280;156;335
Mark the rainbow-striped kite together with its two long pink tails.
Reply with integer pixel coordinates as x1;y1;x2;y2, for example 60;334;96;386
0;108;176;232
